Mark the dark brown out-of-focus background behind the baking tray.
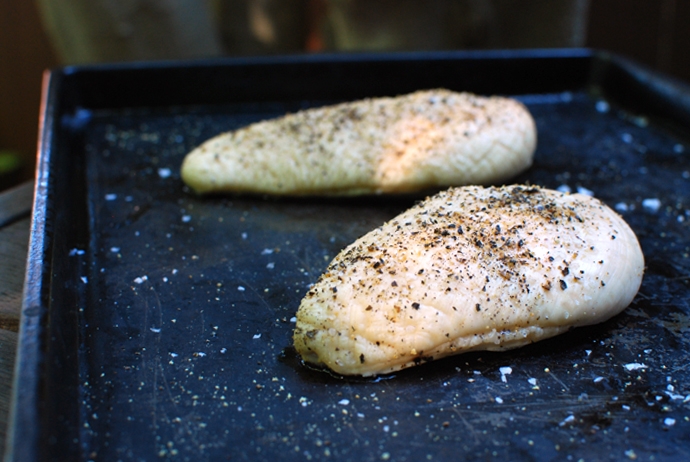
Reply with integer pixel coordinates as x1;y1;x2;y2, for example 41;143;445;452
0;0;690;191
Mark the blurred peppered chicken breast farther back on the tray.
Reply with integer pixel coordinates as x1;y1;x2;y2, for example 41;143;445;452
181;90;536;195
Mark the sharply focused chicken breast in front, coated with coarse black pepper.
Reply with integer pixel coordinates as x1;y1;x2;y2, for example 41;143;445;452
294;185;644;376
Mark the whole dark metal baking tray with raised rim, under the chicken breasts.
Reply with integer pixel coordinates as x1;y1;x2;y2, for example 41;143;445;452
7;50;690;461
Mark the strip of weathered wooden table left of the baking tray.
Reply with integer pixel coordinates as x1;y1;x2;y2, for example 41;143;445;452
0;182;34;458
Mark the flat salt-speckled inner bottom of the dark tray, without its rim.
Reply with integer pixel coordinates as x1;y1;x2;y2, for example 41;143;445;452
12;52;690;460
